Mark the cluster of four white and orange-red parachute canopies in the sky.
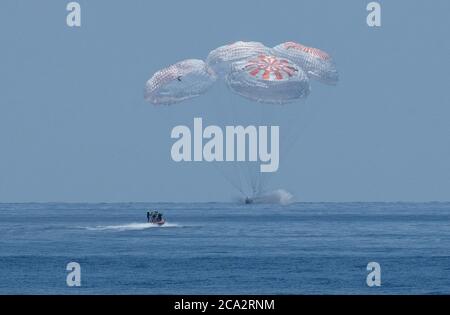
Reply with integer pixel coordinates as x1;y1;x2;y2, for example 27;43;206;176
145;41;339;105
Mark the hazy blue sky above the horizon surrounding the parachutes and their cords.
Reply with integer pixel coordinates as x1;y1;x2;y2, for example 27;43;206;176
0;0;450;202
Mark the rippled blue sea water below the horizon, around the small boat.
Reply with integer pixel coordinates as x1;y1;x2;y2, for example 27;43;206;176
0;203;450;294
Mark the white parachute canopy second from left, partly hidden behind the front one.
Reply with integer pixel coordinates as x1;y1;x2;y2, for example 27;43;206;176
206;41;271;76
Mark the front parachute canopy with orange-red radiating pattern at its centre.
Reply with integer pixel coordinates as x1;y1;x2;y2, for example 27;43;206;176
227;55;310;104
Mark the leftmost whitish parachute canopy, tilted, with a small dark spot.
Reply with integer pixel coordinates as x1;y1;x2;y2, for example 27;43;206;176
144;59;216;105
